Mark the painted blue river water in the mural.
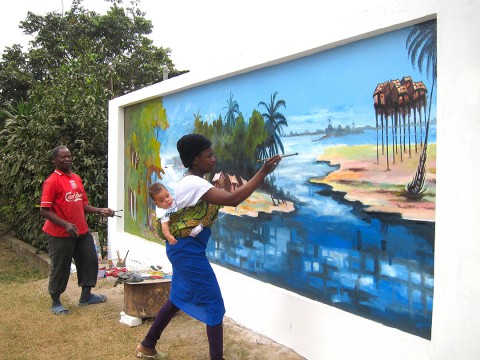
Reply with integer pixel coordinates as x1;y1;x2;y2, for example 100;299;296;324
203;127;435;339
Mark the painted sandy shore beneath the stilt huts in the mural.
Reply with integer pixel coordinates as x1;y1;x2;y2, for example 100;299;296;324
309;144;436;222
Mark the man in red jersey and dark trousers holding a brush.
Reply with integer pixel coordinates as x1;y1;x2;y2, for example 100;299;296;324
40;145;114;315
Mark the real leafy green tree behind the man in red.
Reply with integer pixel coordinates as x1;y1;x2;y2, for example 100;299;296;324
0;0;186;248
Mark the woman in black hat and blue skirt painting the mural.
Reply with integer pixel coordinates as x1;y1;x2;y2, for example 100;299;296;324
136;134;282;360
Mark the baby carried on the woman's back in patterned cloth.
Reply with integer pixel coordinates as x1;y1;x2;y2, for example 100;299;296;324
148;183;203;245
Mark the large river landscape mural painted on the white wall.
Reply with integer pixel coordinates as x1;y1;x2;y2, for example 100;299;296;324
125;20;436;339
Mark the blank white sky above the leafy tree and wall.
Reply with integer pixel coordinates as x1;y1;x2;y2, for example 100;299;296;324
0;0;330;72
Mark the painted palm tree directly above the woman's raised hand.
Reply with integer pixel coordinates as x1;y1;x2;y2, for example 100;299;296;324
258;91;288;159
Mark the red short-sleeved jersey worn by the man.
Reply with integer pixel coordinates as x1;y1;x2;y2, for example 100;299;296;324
40;169;88;237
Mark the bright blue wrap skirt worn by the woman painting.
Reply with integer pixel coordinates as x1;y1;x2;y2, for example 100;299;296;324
166;228;225;326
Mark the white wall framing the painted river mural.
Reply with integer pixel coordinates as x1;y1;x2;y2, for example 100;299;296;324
108;0;480;360
